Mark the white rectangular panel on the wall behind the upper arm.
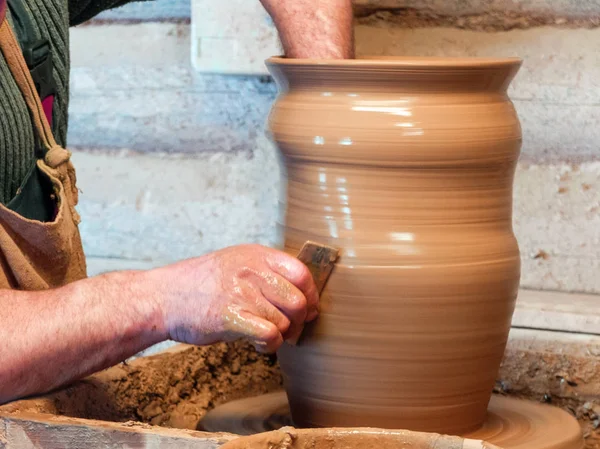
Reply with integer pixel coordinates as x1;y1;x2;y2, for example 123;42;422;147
192;0;281;75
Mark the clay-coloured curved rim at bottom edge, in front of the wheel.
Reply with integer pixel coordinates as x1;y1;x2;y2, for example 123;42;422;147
222;427;500;449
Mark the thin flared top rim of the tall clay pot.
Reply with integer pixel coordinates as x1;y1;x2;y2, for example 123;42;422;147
265;56;523;69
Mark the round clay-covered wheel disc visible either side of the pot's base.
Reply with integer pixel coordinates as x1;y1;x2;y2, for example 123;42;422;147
198;392;583;449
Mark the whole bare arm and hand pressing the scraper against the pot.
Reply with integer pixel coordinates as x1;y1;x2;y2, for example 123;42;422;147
0;245;318;404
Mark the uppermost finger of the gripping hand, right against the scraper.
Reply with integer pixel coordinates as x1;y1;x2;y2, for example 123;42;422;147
266;250;319;323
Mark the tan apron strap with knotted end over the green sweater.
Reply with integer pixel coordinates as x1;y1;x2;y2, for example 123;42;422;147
0;18;63;168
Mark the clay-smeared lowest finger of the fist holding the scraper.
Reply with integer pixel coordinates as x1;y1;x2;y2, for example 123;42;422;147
227;306;283;353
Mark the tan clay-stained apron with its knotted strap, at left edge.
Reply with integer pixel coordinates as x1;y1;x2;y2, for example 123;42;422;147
0;13;86;290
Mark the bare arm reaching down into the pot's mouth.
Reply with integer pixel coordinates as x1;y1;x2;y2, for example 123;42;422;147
261;0;354;59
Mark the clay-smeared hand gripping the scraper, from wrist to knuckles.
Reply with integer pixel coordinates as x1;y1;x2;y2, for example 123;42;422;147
148;245;319;352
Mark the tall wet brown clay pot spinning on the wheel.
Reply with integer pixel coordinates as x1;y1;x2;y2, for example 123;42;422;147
267;58;521;433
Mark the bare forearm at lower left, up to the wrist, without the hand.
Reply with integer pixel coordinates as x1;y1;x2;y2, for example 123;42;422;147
0;272;167;403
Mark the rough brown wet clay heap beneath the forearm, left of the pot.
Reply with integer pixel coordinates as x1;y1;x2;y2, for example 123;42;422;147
0;342;281;429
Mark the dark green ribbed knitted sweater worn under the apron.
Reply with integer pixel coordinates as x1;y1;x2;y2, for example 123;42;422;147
0;0;139;204
